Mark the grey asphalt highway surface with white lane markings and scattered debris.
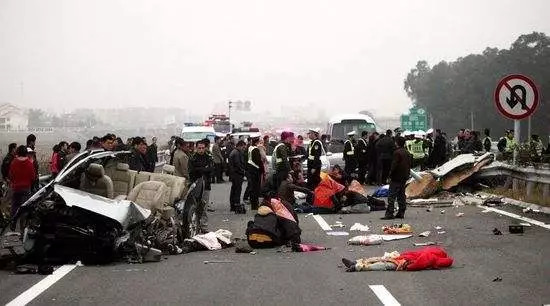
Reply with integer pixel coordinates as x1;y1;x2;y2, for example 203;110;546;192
0;183;550;305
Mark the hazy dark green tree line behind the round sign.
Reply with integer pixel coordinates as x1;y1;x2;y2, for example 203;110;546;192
404;32;550;141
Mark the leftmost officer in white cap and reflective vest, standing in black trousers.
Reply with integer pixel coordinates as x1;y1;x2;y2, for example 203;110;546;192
246;137;265;210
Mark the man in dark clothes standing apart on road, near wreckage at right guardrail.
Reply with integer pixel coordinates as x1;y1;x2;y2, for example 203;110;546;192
382;137;412;220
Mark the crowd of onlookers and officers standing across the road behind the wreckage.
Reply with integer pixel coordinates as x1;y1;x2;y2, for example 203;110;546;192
2;128;550;226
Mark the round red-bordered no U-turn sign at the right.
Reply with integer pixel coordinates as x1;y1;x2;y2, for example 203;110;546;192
495;74;539;119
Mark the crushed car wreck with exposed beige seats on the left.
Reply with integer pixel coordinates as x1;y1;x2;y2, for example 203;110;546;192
0;150;205;264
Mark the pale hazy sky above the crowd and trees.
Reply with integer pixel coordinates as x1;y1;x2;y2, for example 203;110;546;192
0;0;550;114
